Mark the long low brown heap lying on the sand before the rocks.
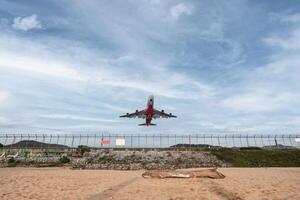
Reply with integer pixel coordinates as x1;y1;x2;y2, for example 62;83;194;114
142;169;225;179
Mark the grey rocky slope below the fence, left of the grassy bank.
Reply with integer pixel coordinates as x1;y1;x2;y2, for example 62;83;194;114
71;150;225;170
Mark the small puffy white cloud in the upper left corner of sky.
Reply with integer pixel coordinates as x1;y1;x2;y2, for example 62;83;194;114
12;15;42;31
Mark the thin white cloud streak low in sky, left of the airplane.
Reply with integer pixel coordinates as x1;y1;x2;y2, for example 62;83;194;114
40;114;119;122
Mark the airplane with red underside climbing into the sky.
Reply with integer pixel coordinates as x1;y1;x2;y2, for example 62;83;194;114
120;95;177;126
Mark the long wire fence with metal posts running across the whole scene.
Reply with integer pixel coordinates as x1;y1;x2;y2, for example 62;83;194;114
0;132;300;148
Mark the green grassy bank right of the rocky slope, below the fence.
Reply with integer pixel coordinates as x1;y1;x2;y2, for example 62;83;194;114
211;148;300;167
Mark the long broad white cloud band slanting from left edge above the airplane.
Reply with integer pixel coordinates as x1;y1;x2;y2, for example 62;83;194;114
0;32;214;99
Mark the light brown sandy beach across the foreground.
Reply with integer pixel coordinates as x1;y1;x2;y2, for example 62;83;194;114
0;168;300;200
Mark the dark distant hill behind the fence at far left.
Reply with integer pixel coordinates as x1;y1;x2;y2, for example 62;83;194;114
5;140;69;149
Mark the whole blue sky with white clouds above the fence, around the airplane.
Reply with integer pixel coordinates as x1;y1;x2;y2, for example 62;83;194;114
0;0;300;133
